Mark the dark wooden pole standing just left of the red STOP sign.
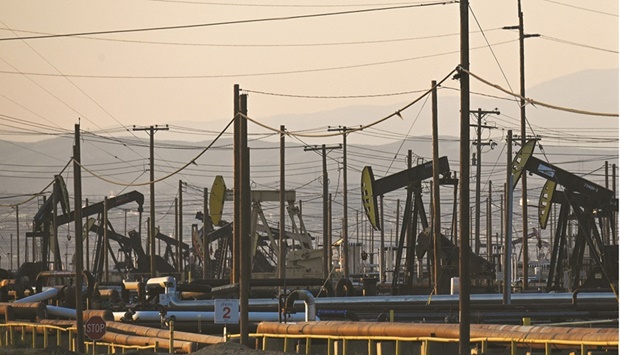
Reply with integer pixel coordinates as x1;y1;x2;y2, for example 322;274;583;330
72;124;88;354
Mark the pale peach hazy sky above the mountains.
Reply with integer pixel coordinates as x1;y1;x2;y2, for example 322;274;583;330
0;0;618;139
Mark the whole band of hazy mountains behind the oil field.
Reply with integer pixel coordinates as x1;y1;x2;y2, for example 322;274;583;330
0;69;618;238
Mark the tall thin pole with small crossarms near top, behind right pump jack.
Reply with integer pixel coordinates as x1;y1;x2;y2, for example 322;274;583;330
502;0;540;290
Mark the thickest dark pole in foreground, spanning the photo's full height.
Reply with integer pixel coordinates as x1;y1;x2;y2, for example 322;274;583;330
459;0;471;355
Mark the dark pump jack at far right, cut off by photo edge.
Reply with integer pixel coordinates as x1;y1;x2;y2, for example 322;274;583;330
512;140;618;293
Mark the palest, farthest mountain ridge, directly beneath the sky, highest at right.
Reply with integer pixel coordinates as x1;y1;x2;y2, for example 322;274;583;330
167;68;619;145
